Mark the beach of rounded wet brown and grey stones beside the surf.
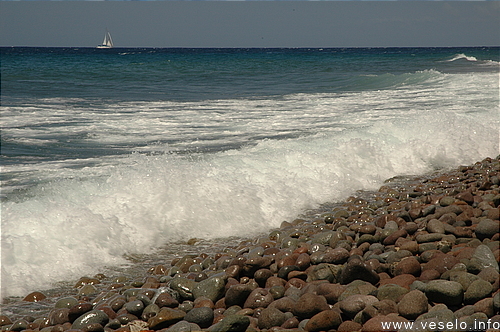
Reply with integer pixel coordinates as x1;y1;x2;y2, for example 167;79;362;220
0;156;500;332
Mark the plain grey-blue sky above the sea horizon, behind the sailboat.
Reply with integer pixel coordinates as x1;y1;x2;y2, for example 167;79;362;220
0;1;500;47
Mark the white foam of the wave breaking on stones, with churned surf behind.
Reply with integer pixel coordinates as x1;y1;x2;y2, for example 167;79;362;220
2;70;500;296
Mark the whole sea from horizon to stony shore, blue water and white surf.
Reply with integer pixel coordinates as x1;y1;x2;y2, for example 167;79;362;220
0;47;500;297
